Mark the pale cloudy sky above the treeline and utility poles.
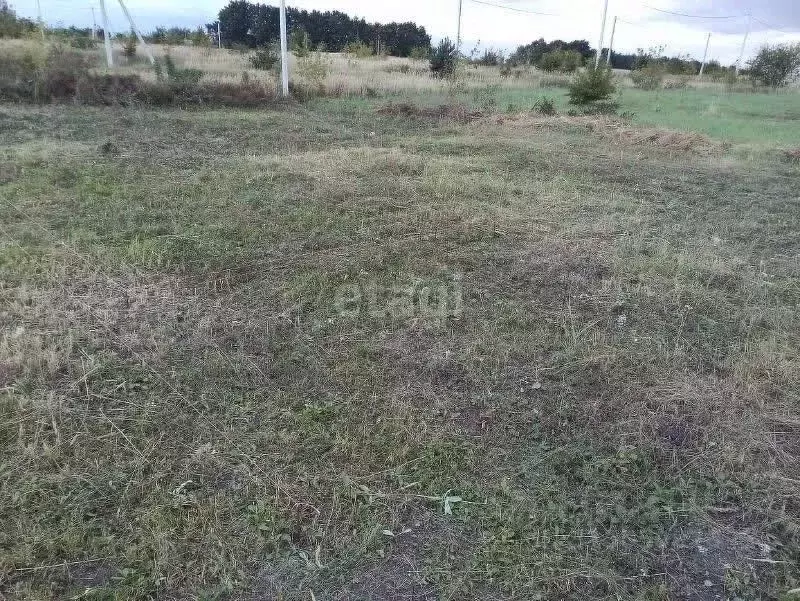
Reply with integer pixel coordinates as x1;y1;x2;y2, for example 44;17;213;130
18;0;800;64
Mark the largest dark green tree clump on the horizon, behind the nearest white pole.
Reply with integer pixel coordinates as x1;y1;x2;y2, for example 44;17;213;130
214;0;431;56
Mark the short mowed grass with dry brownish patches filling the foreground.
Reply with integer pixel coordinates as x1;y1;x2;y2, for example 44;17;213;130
0;100;800;601
